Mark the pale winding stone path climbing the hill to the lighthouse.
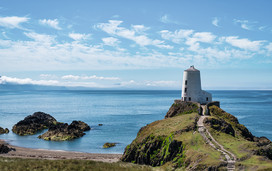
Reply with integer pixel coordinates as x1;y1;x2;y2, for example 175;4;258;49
197;107;236;171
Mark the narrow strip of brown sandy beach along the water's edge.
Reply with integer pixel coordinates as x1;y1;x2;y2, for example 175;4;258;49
0;140;122;163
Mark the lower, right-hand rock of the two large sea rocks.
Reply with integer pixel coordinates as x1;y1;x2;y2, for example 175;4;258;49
38;121;90;141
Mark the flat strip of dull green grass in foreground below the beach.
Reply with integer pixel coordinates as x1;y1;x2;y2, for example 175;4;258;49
0;157;154;171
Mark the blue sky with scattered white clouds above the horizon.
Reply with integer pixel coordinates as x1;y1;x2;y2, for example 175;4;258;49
0;0;272;90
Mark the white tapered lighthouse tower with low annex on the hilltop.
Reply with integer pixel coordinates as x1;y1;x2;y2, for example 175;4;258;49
181;66;212;104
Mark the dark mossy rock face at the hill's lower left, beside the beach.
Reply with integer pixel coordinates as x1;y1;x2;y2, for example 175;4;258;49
121;135;185;166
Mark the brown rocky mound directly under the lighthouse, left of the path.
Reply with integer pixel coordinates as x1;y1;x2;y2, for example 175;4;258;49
165;100;199;119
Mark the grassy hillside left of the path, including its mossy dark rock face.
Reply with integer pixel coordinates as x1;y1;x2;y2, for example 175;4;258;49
122;113;222;170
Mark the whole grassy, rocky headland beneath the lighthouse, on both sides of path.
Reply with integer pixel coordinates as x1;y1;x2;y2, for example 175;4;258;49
121;102;272;170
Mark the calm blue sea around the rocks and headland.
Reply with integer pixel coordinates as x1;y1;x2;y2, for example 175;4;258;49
0;90;272;154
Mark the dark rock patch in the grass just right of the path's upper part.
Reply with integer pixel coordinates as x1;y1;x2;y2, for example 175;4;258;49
204;118;235;137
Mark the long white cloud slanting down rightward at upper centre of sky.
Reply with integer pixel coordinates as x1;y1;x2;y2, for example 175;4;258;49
96;20;173;49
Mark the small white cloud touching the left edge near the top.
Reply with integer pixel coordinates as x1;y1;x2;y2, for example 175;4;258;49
0;16;29;29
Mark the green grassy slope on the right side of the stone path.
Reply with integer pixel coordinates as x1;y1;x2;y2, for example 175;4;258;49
207;106;272;170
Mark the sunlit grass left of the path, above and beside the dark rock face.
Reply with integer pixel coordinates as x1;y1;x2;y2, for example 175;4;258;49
132;113;222;170
